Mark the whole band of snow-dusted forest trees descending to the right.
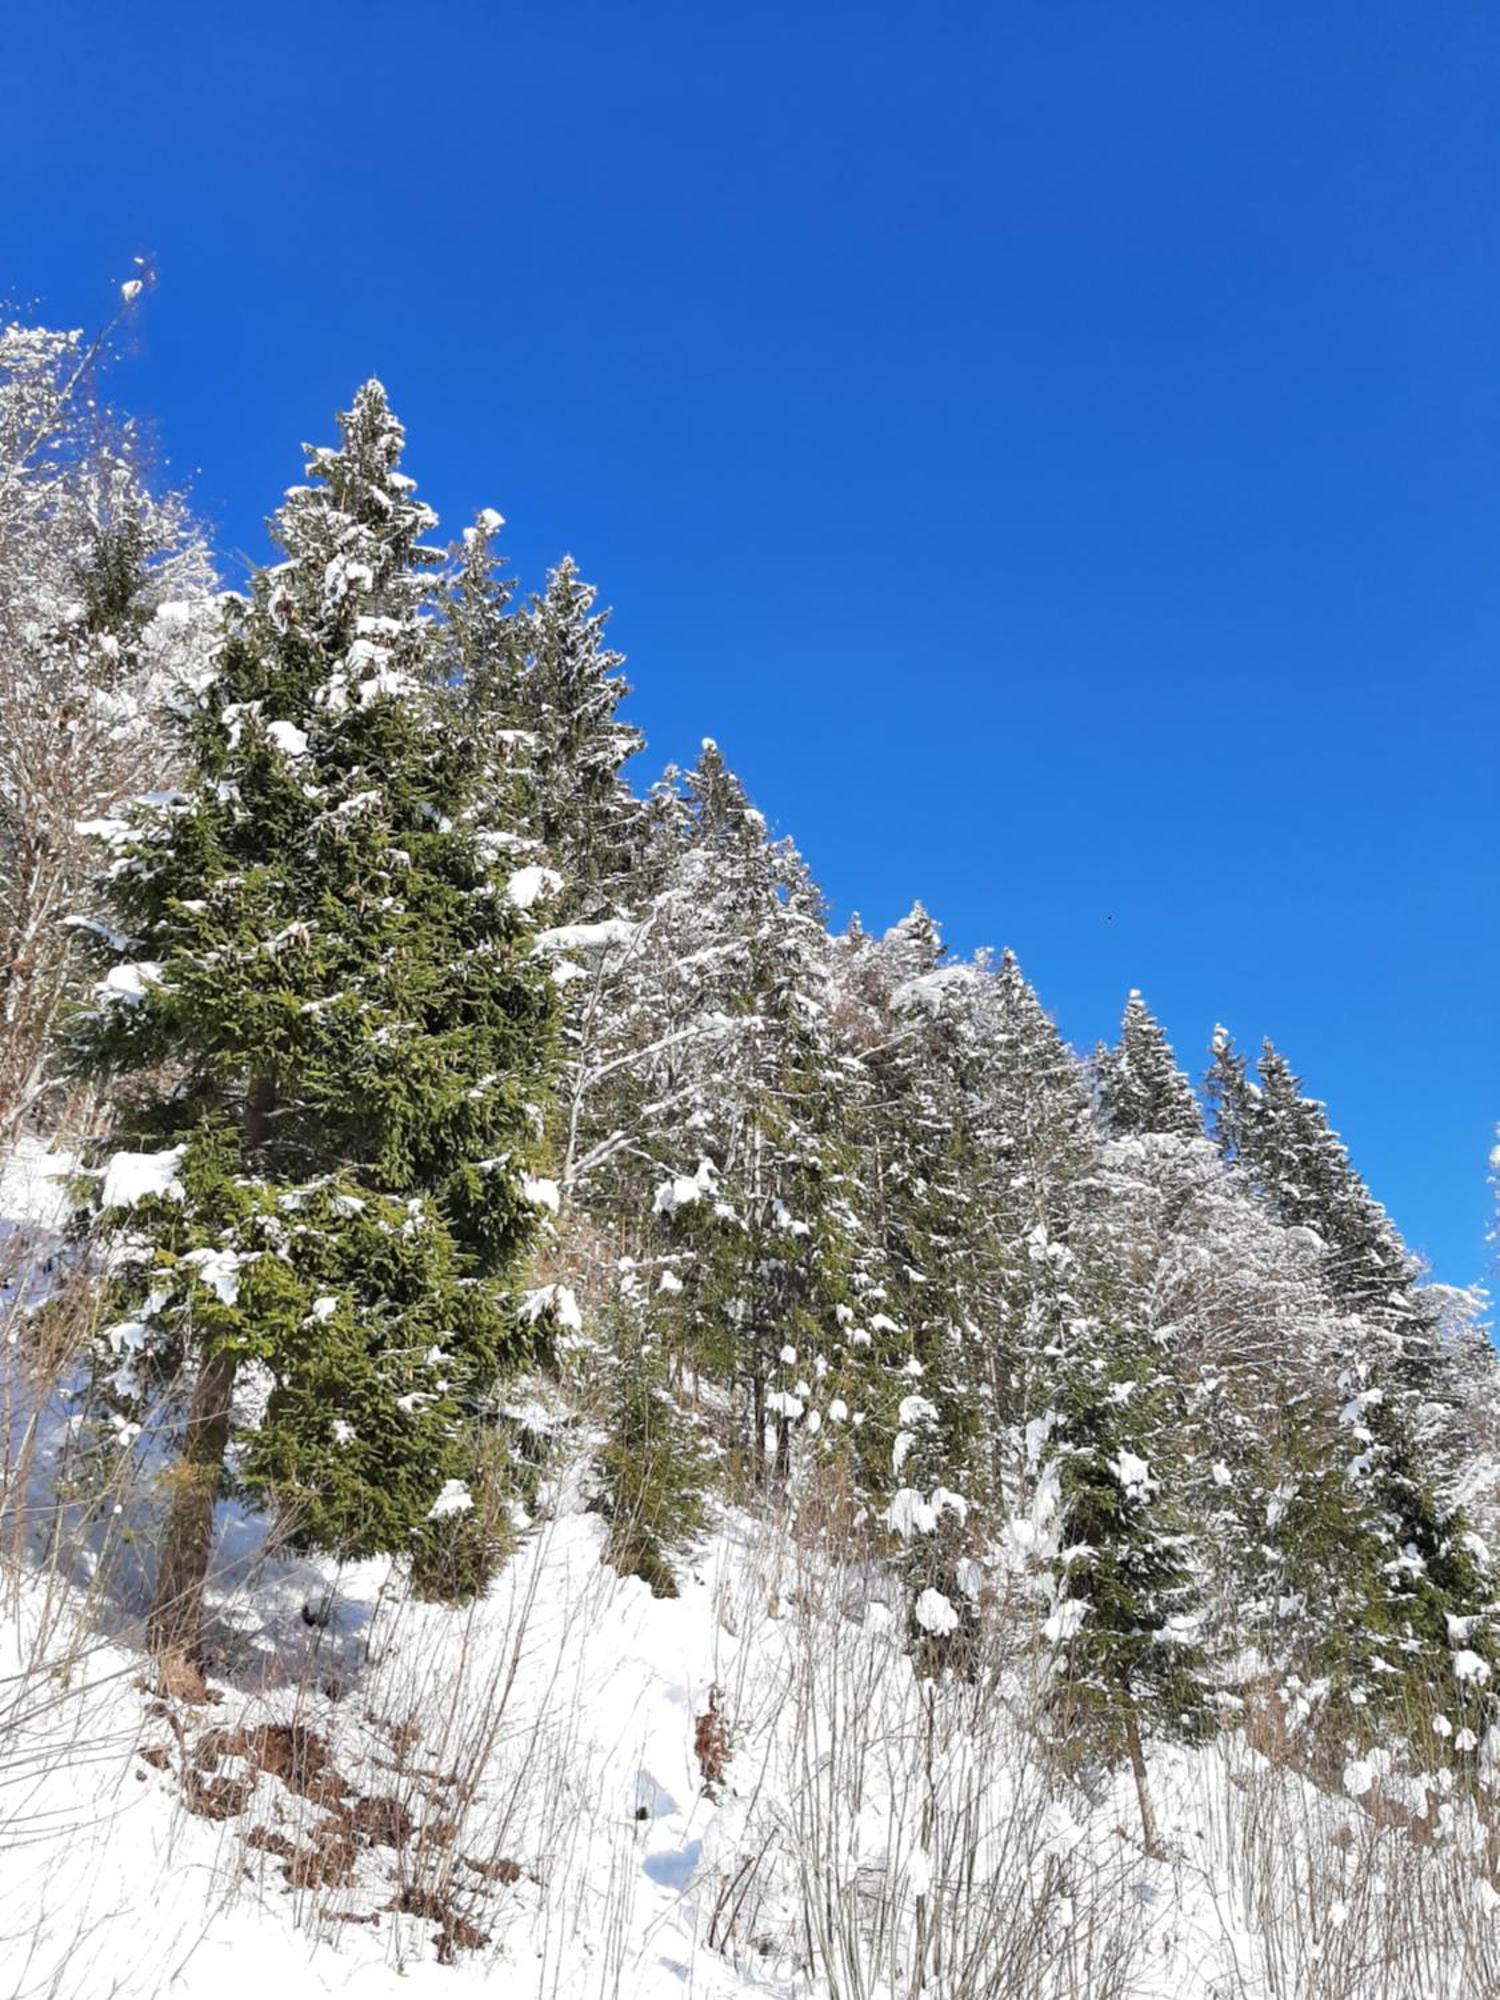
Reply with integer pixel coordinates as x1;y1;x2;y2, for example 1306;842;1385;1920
0;308;1500;1816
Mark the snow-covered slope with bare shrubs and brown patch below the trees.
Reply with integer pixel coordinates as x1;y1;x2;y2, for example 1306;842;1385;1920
0;1506;1494;2000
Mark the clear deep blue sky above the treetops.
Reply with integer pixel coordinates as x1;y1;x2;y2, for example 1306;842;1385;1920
0;0;1500;1282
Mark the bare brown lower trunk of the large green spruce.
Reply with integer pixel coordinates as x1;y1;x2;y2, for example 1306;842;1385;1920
146;1354;236;1702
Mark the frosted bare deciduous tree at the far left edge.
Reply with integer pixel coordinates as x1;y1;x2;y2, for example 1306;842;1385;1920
0;292;214;1140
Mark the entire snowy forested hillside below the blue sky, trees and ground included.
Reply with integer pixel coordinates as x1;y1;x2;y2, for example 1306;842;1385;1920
0;330;1500;2000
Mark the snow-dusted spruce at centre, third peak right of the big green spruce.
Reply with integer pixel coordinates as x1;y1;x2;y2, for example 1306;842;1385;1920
614;742;852;1476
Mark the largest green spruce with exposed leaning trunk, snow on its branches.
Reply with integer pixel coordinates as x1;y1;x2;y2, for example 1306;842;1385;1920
78;382;554;1686
